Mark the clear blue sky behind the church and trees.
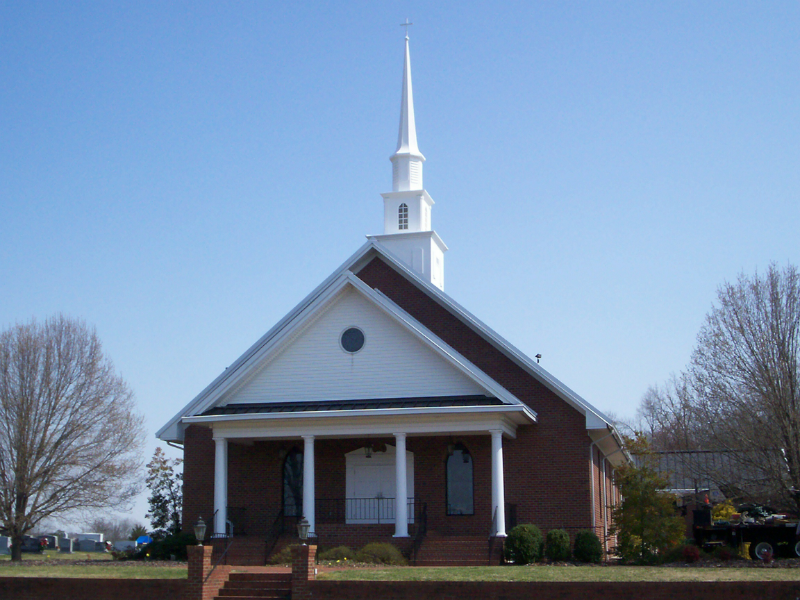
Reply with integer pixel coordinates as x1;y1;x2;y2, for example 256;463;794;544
0;0;800;518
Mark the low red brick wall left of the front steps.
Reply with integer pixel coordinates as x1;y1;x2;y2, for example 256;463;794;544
0;577;186;600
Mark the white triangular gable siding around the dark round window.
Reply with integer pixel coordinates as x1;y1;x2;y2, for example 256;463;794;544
223;288;486;404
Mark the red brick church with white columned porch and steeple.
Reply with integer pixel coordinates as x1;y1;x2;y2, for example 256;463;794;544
157;37;627;565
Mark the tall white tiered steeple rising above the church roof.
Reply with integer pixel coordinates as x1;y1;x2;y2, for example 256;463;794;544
367;32;447;290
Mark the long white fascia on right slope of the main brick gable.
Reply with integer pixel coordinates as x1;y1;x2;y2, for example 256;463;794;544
356;241;612;429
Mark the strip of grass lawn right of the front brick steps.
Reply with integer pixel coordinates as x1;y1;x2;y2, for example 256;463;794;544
319;565;800;581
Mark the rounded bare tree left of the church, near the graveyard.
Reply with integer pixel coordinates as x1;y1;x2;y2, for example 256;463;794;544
0;315;144;560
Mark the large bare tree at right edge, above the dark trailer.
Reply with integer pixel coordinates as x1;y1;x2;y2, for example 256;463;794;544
689;264;800;509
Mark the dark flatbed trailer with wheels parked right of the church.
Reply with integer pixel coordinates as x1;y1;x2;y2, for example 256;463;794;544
692;510;800;560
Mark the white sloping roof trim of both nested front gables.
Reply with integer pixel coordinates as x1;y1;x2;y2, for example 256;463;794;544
156;236;613;440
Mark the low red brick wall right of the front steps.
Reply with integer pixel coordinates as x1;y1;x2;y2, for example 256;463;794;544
308;580;800;600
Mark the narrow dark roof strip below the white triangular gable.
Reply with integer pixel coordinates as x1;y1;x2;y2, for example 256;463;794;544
203;395;505;416
